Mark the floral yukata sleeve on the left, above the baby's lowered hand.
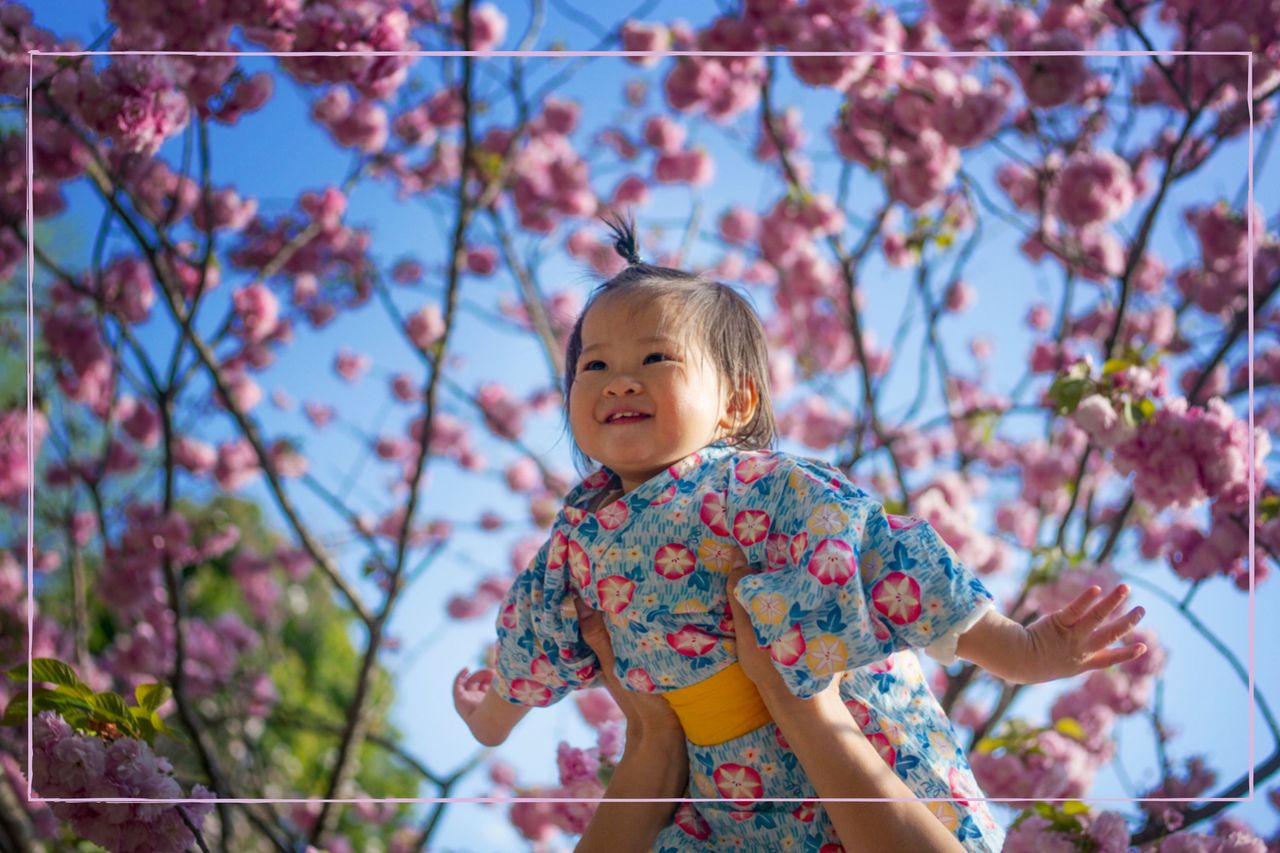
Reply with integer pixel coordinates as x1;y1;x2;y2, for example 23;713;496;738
493;533;599;707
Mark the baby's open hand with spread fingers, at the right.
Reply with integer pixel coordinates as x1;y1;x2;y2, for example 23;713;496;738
1021;584;1147;684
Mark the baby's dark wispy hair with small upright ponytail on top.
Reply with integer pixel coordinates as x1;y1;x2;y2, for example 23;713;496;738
564;207;777;471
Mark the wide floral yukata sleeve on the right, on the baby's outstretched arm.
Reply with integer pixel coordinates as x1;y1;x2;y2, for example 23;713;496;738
726;455;991;697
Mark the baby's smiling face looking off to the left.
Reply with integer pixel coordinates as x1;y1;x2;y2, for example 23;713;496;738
568;297;732;492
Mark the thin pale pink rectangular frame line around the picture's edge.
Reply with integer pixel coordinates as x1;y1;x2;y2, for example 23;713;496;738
27;44;1257;804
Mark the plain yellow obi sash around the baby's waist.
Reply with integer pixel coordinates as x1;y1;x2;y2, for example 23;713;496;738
662;661;773;747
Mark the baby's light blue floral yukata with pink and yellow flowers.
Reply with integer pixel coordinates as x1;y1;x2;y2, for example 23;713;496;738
493;442;1004;853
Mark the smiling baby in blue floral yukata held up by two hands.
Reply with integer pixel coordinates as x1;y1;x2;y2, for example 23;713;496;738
454;212;1146;853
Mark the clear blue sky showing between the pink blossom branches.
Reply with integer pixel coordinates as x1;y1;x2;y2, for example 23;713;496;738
20;1;1280;850
